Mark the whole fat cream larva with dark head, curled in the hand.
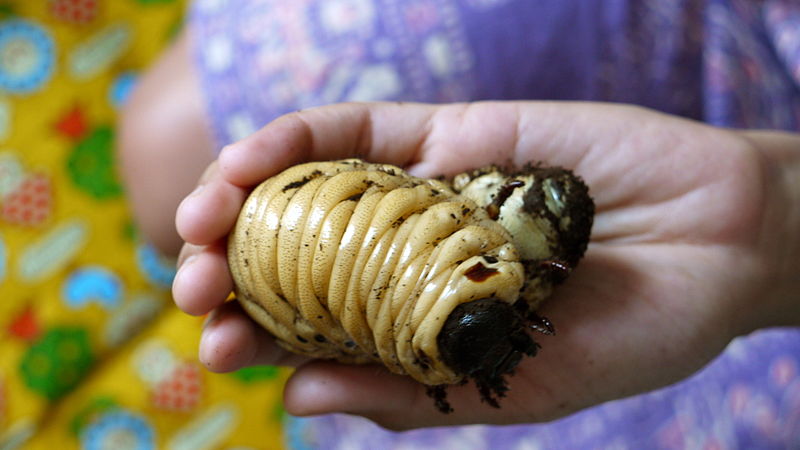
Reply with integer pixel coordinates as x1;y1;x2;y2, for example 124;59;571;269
228;159;594;411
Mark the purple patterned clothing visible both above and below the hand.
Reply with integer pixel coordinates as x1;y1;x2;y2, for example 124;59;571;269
190;0;800;450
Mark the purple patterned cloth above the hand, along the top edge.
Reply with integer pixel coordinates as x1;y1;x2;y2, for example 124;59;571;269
190;0;800;153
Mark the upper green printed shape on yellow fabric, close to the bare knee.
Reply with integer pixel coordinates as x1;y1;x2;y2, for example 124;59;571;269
67;126;122;199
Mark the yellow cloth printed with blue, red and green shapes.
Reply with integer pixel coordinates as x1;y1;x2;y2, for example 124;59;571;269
0;0;286;449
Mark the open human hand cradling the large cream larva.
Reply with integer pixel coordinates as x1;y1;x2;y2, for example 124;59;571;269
173;102;800;429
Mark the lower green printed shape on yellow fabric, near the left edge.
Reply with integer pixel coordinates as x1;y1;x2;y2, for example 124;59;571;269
19;327;94;400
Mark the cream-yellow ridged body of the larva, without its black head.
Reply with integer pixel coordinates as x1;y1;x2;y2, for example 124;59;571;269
229;161;536;384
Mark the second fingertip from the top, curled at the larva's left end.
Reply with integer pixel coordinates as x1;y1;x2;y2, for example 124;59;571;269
175;171;247;245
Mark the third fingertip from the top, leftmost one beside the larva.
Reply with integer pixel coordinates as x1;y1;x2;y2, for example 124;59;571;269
172;242;233;316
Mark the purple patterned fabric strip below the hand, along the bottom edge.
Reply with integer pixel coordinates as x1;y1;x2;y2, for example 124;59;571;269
287;330;800;450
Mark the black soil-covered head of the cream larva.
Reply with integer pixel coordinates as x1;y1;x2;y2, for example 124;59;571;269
437;298;538;407
